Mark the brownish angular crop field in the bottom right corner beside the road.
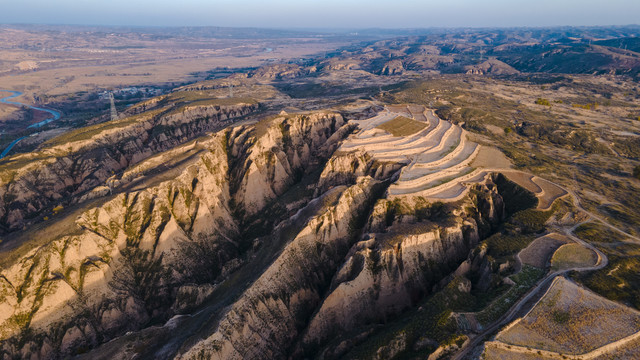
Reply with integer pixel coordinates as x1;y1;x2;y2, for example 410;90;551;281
496;277;640;355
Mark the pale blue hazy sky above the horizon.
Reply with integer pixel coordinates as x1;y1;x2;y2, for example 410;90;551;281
0;0;640;28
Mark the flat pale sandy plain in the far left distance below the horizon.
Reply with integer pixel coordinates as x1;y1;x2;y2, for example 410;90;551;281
0;28;348;98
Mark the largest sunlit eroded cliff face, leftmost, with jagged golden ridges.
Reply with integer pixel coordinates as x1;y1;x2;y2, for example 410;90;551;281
0;113;348;358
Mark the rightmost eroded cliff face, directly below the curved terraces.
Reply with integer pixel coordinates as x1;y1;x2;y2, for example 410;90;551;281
298;181;504;353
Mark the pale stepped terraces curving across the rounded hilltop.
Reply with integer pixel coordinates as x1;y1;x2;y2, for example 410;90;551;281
341;106;486;201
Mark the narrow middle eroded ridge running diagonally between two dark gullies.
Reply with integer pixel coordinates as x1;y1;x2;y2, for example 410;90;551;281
182;177;379;359
